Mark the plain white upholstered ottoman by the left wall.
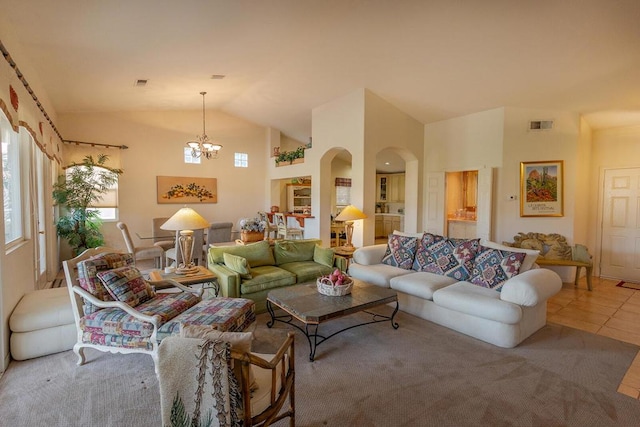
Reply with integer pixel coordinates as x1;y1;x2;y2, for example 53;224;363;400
9;287;78;360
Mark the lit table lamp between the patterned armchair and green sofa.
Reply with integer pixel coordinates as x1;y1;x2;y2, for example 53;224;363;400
160;206;209;274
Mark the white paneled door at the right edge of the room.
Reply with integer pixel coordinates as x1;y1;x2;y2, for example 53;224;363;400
600;168;640;282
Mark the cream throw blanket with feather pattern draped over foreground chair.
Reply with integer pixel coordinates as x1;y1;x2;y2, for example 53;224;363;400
158;337;242;427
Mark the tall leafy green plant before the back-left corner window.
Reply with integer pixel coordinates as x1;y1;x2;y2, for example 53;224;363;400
53;154;123;255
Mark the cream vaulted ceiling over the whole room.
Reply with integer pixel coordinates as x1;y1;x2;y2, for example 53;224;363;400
0;0;640;142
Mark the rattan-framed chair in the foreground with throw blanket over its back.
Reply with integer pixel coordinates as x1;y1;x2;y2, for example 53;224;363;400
158;332;295;427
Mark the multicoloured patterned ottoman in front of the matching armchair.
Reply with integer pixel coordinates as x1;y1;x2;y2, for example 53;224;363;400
157;297;256;342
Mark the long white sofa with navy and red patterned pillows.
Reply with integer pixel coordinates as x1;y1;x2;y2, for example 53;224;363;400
348;232;562;348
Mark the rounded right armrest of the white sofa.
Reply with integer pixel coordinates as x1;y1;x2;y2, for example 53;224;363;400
500;268;562;307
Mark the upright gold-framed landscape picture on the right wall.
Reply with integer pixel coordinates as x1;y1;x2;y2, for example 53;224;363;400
520;160;564;216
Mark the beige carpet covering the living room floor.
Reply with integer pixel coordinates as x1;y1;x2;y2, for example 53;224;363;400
0;313;640;426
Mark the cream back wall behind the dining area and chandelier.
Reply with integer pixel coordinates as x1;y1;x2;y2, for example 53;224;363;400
59;111;269;254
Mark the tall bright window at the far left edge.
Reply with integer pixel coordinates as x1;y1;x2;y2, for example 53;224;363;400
0;113;24;244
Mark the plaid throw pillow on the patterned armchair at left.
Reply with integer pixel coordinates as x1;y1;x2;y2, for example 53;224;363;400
96;267;155;307
